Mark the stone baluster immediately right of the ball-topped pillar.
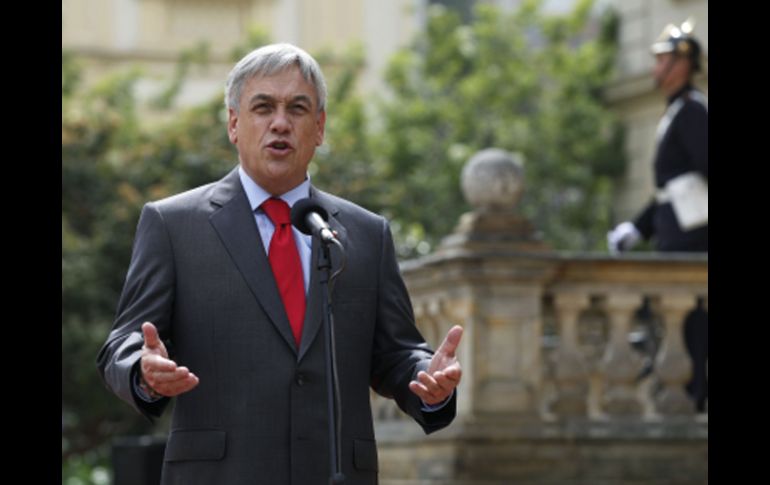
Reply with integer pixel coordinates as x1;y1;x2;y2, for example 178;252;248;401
550;293;589;416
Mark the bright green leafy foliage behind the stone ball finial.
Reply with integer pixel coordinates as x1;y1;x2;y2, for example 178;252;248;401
376;1;624;250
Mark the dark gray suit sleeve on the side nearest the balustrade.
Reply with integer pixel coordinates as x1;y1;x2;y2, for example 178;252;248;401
372;219;457;433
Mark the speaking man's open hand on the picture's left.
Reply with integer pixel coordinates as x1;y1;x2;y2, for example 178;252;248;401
140;322;199;397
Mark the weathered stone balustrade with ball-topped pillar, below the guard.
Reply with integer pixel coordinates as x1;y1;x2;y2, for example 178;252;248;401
372;151;708;485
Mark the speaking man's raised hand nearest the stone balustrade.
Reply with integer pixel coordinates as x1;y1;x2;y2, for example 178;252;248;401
409;325;463;406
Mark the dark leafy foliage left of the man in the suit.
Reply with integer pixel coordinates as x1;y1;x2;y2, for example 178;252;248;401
62;47;234;470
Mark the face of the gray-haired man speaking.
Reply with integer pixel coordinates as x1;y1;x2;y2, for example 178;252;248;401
227;66;326;196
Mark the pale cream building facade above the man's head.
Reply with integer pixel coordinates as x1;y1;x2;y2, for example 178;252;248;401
62;0;425;106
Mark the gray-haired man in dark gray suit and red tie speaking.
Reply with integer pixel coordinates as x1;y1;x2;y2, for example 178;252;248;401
97;44;462;485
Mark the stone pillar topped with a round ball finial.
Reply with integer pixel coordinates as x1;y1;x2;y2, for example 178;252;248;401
436;149;551;417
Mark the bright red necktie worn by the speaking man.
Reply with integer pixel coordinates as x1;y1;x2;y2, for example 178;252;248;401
262;199;305;347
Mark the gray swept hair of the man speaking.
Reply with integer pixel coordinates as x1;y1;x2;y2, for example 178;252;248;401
225;44;326;113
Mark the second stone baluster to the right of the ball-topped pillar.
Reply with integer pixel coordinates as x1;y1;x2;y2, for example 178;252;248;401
601;293;642;416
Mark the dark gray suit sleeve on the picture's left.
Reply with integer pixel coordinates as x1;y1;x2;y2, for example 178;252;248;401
96;204;174;419
